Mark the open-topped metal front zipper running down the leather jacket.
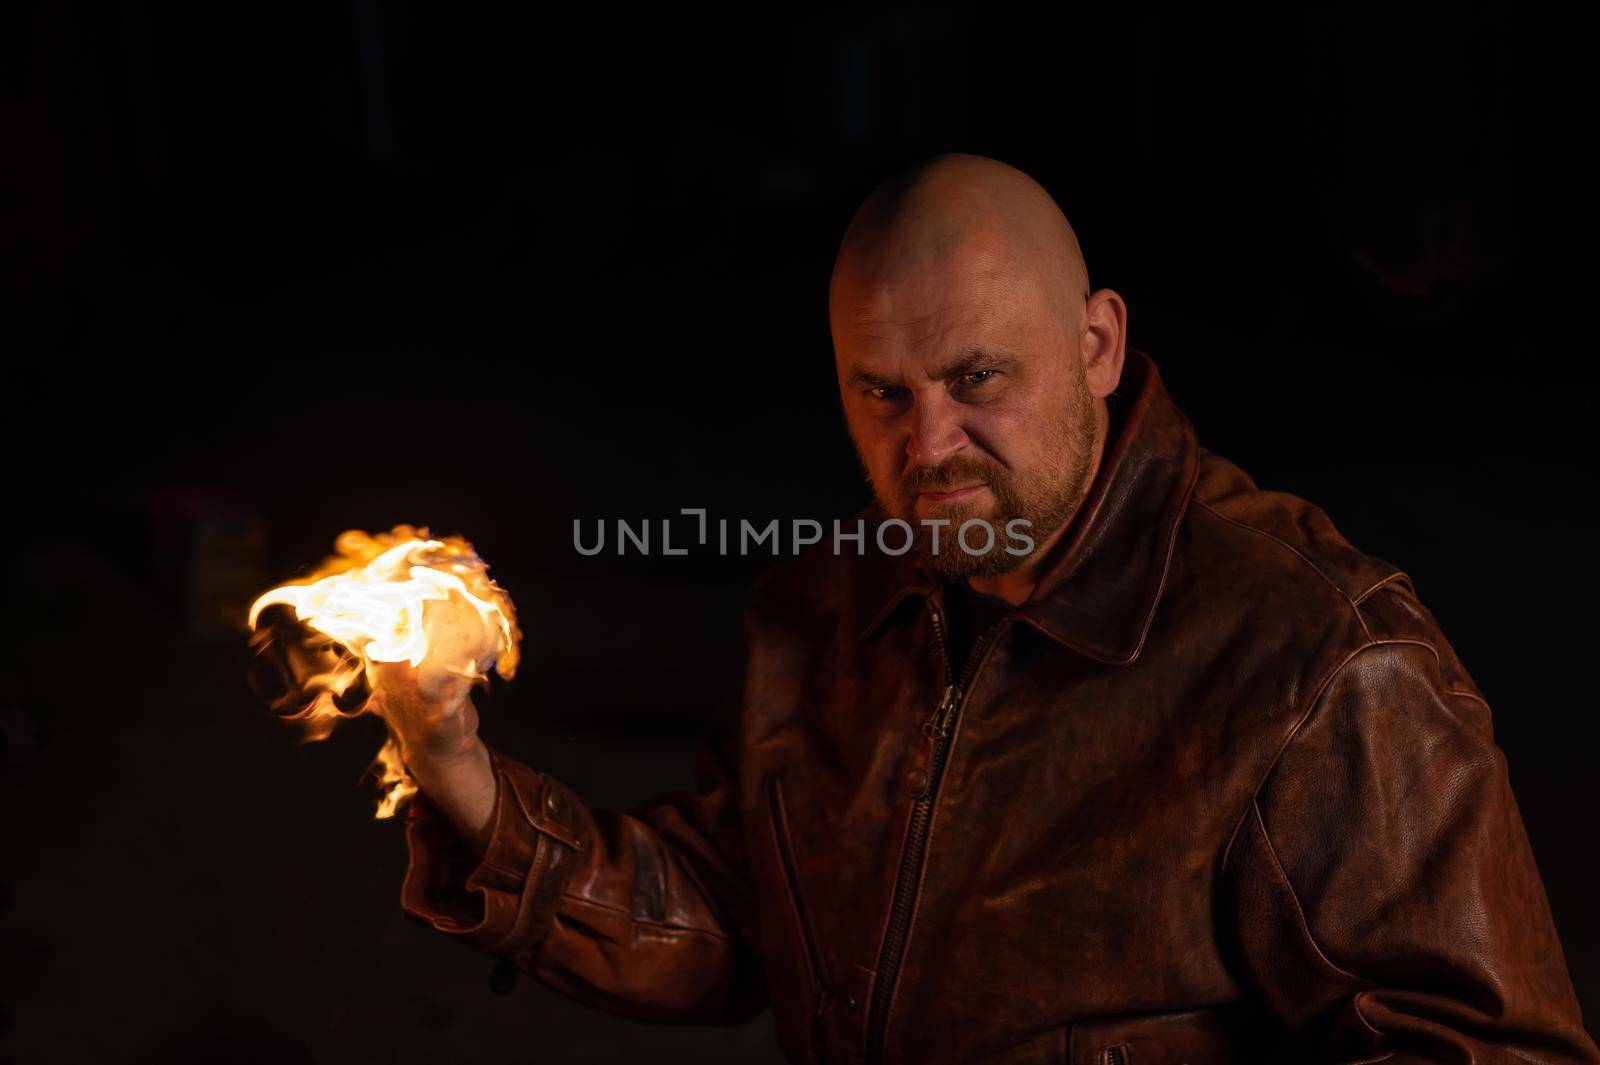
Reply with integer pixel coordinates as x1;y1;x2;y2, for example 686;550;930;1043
867;608;1005;1062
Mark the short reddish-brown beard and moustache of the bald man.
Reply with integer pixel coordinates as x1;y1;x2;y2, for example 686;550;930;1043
858;363;1101;579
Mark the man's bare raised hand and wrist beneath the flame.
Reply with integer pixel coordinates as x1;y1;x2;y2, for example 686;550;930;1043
373;662;494;854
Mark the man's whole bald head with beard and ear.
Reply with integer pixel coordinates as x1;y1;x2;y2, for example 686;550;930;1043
829;155;1126;577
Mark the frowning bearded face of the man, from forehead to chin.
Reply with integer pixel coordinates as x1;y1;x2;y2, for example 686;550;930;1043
832;253;1101;577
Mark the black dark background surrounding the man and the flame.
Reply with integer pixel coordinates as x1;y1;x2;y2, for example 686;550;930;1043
0;0;1600;1062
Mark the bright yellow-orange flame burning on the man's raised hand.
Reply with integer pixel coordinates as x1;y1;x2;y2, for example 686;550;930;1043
250;525;522;817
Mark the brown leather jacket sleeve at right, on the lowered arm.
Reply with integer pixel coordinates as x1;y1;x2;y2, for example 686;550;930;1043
1226;641;1600;1065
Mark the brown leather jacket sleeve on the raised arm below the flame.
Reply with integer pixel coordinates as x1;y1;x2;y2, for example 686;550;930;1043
402;729;766;1023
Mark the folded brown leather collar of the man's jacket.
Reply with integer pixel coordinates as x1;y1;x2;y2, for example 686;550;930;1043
864;350;1200;665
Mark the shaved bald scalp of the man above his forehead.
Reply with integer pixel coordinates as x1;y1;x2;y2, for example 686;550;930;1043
829;155;1088;329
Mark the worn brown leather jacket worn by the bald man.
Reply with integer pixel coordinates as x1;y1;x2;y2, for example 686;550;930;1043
403;353;1600;1065
